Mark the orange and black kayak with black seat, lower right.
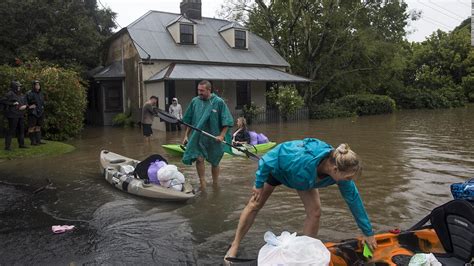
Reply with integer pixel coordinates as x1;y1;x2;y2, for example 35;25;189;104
226;199;474;266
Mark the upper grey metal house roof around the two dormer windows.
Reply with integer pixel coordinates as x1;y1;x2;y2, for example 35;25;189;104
127;11;289;67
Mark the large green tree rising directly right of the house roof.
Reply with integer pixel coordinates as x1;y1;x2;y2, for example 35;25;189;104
221;0;410;106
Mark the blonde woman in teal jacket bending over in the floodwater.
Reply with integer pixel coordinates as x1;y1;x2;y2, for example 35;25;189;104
225;138;377;258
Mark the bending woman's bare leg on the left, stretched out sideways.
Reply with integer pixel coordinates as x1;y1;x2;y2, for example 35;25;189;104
226;183;275;257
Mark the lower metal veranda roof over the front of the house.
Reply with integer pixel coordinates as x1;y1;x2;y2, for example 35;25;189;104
146;64;311;82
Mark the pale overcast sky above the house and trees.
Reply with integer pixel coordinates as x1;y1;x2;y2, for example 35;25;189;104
98;0;471;41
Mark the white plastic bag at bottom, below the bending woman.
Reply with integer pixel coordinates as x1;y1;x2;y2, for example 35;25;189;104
258;231;331;266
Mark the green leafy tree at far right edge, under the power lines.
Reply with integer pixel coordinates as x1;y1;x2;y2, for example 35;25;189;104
396;19;474;108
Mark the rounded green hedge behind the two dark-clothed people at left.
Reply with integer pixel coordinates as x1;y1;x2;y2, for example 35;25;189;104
0;61;86;140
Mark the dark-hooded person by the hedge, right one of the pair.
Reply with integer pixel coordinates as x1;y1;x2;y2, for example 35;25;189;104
26;80;46;145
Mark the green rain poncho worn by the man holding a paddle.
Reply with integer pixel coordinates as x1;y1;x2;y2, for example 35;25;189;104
183;93;234;166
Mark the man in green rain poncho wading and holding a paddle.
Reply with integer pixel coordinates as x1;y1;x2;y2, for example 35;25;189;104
183;80;234;189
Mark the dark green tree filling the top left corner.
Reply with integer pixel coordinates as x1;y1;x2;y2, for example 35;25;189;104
0;0;116;68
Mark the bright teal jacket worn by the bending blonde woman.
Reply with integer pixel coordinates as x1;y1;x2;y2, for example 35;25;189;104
255;138;374;236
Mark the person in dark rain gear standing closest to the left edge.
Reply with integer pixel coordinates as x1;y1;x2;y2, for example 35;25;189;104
1;81;27;151
